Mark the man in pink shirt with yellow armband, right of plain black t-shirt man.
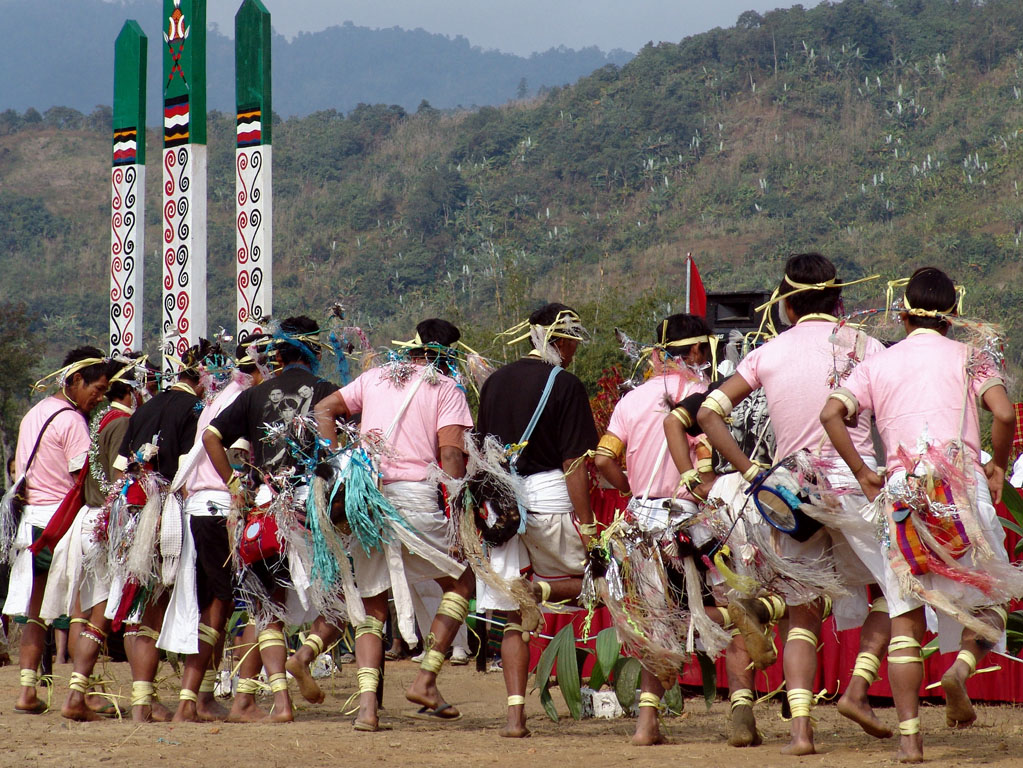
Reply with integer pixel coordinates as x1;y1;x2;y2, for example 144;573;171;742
594;315;756;747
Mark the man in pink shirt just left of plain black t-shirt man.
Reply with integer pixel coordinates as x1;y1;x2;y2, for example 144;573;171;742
316;318;476;731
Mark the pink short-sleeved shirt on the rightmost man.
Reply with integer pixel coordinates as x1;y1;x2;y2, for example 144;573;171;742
843;331;1002;466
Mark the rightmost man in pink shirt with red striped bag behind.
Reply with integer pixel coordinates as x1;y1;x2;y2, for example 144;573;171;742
820;267;1023;762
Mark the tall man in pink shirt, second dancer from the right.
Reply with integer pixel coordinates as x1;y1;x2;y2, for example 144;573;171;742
698;254;891;755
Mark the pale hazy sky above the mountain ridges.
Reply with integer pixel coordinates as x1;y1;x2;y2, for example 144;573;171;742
199;0;817;55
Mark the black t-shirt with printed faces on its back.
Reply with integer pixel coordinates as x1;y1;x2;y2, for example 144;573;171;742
210;365;338;472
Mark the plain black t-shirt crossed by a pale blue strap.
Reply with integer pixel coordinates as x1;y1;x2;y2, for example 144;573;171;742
476;358;597;476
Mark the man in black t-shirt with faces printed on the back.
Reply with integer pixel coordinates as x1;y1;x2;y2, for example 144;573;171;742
203;315;338;722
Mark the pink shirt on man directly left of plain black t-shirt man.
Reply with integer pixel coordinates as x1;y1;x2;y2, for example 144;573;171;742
341;367;473;483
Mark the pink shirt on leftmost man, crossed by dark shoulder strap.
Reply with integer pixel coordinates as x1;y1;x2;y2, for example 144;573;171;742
14;397;90;505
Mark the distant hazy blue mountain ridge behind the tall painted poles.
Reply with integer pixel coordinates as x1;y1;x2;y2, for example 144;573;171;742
0;0;633;117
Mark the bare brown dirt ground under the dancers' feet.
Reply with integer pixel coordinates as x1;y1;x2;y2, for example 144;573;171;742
0;662;1023;768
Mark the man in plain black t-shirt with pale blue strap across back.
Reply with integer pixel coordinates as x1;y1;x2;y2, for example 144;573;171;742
477;304;597;738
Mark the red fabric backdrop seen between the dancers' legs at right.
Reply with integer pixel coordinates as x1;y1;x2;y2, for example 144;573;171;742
530;489;1023;703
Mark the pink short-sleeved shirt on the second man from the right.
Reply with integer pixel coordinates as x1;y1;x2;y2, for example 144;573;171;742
737;320;884;459
